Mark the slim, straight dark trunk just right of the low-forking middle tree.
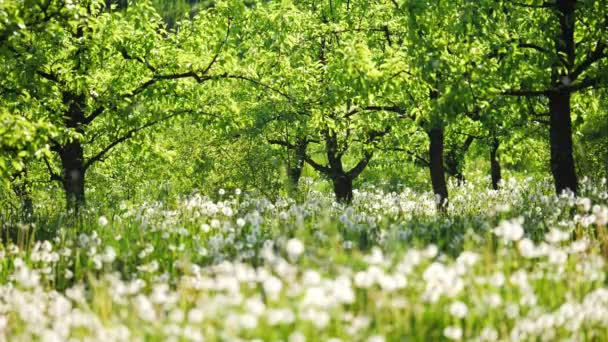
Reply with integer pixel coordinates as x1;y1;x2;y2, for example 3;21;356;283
428;128;448;211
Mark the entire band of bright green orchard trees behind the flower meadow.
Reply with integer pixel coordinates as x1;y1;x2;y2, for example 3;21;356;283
0;0;608;209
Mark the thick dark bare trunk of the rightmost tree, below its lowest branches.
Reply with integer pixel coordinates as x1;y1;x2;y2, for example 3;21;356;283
549;91;578;195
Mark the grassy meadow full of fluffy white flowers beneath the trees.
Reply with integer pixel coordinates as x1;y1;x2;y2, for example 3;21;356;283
0;181;608;342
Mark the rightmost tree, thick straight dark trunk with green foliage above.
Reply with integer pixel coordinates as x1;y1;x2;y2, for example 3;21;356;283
485;0;608;194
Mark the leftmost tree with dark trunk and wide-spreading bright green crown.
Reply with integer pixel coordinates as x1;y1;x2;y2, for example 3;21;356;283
0;1;245;209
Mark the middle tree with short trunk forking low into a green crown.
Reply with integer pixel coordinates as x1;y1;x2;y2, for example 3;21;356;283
251;1;395;203
